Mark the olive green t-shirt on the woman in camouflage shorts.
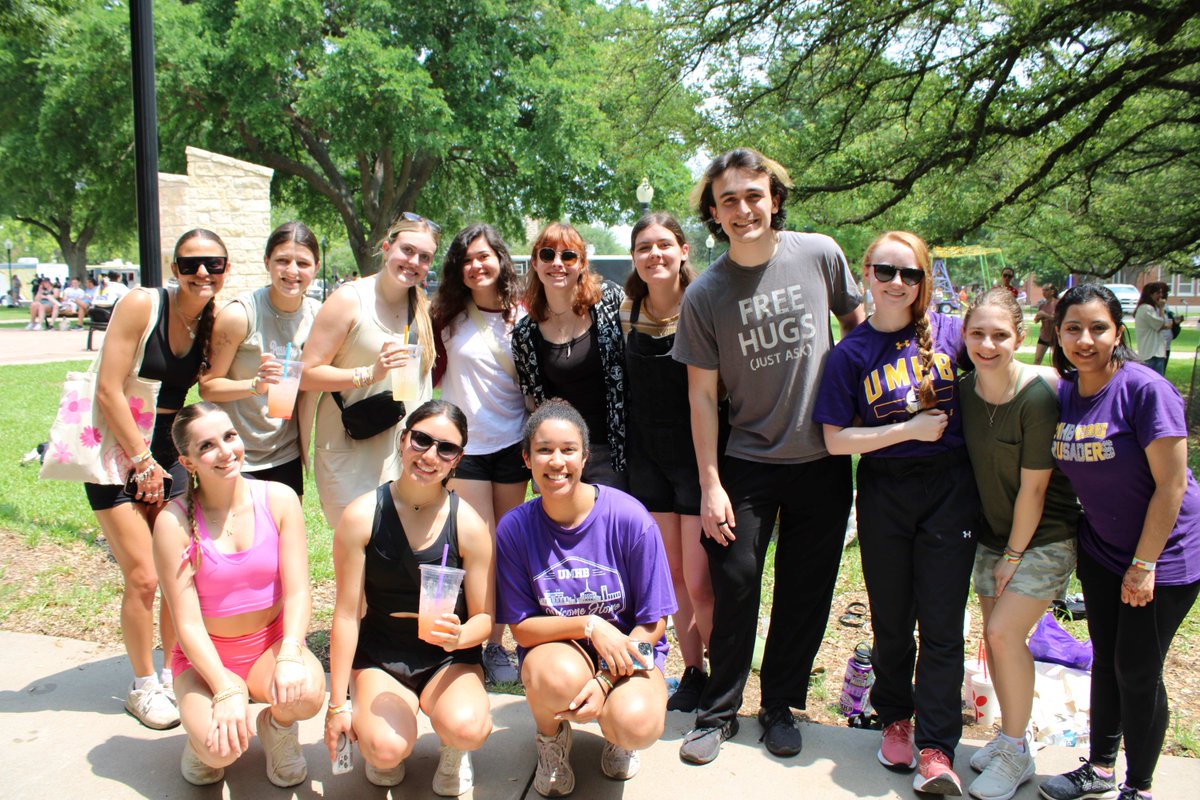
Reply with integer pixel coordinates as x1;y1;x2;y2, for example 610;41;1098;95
959;372;1080;551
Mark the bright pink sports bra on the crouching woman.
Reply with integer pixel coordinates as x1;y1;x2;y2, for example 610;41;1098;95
184;481;283;616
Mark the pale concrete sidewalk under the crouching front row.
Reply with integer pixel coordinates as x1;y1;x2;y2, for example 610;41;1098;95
0;632;1200;800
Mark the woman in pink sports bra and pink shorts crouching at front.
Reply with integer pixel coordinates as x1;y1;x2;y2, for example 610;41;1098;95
154;403;325;787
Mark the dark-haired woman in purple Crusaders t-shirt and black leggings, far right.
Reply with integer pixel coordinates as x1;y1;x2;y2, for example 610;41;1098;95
1042;284;1200;800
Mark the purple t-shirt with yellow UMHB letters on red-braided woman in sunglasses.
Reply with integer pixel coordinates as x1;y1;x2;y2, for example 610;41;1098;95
812;312;965;458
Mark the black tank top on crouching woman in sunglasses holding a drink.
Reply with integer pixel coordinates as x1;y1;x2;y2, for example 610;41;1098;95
359;482;467;655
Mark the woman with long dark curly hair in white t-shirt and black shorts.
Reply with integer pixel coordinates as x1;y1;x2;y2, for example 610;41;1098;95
431;223;529;685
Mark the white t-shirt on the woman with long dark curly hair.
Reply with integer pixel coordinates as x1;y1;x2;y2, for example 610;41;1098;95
442;308;526;456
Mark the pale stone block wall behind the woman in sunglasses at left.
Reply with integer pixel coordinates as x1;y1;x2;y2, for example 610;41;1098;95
158;148;274;302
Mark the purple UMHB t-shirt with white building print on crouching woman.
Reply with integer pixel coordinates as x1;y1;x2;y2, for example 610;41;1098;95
496;486;678;669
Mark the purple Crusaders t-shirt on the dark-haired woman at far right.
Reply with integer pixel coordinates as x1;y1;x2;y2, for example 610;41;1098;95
1051;362;1200;585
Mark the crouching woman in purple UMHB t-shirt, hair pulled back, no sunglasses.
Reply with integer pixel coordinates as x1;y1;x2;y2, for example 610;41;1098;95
496;399;676;798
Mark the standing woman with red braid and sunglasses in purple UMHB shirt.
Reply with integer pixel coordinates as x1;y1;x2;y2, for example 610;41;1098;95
812;231;979;794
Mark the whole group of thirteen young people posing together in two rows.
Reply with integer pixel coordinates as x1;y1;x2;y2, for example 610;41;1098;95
77;149;1200;800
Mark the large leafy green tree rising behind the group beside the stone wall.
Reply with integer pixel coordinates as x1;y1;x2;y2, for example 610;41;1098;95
163;0;695;273
